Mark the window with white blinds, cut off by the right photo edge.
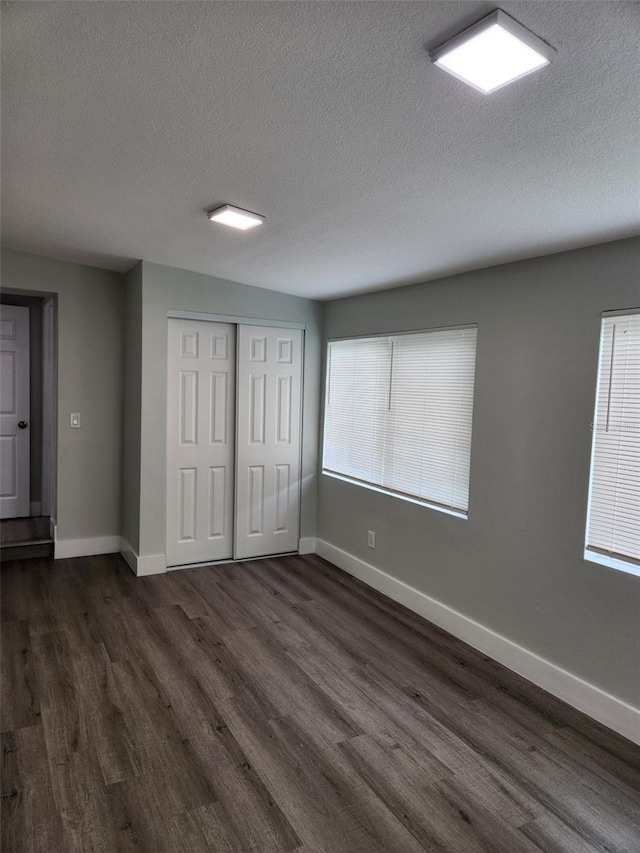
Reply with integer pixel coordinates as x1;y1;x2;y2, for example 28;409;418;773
585;309;640;574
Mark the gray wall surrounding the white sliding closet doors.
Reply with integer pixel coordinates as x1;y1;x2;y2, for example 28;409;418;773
130;261;323;556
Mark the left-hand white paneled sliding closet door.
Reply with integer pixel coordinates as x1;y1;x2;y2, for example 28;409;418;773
167;320;236;566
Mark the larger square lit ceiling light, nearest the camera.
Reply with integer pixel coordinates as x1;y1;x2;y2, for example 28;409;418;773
430;9;555;95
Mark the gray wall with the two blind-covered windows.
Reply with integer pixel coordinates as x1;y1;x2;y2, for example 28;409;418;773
318;239;640;707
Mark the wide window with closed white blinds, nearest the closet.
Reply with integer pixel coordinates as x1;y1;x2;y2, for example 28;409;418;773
322;326;477;517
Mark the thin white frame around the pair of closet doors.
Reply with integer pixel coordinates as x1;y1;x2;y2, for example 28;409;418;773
164;309;307;572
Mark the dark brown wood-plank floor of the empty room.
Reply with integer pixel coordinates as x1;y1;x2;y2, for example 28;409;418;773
2;555;640;853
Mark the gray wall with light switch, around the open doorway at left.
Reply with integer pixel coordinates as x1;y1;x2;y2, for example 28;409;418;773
1;249;124;540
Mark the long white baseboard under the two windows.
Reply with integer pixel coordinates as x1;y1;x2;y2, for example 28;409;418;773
316;539;640;744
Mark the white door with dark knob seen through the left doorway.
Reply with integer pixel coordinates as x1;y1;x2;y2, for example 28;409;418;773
0;305;29;518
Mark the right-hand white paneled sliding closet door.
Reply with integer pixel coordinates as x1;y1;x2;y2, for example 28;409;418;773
234;326;302;559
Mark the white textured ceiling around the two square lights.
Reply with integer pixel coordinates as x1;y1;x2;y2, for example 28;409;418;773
2;2;640;298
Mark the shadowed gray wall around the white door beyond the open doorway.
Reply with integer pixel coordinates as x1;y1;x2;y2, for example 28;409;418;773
0;291;44;503
